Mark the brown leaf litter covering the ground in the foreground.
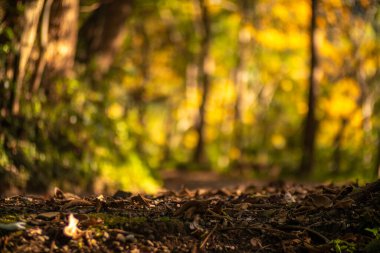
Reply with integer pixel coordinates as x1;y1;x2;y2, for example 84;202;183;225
0;181;380;253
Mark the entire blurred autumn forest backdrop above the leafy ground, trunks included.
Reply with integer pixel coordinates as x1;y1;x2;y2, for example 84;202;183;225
0;0;380;193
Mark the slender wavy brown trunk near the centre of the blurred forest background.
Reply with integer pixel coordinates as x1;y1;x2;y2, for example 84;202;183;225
193;0;211;162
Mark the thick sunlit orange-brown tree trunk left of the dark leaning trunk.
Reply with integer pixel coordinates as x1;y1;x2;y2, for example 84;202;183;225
26;0;79;192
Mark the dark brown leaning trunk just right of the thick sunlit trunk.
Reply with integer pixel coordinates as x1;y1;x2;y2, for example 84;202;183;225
78;0;133;79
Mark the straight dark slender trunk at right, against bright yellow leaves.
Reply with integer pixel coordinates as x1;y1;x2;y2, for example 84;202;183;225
299;0;318;175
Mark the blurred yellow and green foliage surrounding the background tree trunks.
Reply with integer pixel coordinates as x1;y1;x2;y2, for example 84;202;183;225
0;0;380;194
